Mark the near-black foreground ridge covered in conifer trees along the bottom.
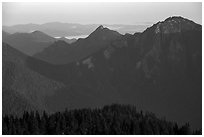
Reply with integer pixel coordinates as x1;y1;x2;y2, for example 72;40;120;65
2;104;202;135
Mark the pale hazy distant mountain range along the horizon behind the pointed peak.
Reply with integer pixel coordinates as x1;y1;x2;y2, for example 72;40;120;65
3;22;150;37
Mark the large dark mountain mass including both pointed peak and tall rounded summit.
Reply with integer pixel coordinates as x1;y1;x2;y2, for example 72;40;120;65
3;17;202;128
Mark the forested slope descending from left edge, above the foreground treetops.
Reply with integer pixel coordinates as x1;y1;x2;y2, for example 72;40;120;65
2;43;64;115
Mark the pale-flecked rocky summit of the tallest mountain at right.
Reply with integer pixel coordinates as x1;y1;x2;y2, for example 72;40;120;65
155;16;201;34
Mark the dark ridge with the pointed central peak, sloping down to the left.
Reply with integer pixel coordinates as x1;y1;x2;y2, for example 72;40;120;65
34;26;122;64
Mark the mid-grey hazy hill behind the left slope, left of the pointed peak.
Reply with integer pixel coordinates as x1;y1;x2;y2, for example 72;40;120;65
2;31;56;55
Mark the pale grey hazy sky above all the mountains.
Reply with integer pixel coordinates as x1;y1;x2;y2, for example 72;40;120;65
2;2;202;25
